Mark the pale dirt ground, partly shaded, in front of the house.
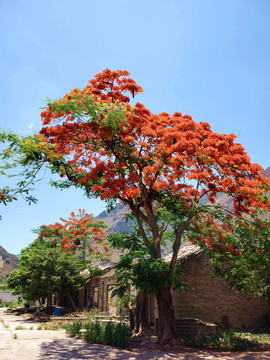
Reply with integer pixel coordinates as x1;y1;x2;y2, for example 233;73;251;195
0;308;270;360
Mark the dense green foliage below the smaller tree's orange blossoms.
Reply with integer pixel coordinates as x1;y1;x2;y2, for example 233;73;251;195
7;239;89;301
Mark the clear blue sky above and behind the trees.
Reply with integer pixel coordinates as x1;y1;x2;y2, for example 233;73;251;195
0;0;270;254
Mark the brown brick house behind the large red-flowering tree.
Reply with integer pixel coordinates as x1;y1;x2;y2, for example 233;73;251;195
78;244;270;329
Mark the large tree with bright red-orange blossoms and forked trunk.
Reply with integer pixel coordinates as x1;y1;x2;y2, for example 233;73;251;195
25;69;269;342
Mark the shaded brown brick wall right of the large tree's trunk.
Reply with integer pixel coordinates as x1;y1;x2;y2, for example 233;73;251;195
170;253;270;328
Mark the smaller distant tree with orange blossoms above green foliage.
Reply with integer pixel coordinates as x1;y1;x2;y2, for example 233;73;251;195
7;210;110;309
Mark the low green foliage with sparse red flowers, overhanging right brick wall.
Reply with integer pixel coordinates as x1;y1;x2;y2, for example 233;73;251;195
188;214;270;296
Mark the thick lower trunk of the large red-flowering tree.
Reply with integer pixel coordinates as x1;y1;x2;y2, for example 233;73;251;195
155;284;177;344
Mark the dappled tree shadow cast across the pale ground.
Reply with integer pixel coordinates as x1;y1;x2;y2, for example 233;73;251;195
38;338;270;360
